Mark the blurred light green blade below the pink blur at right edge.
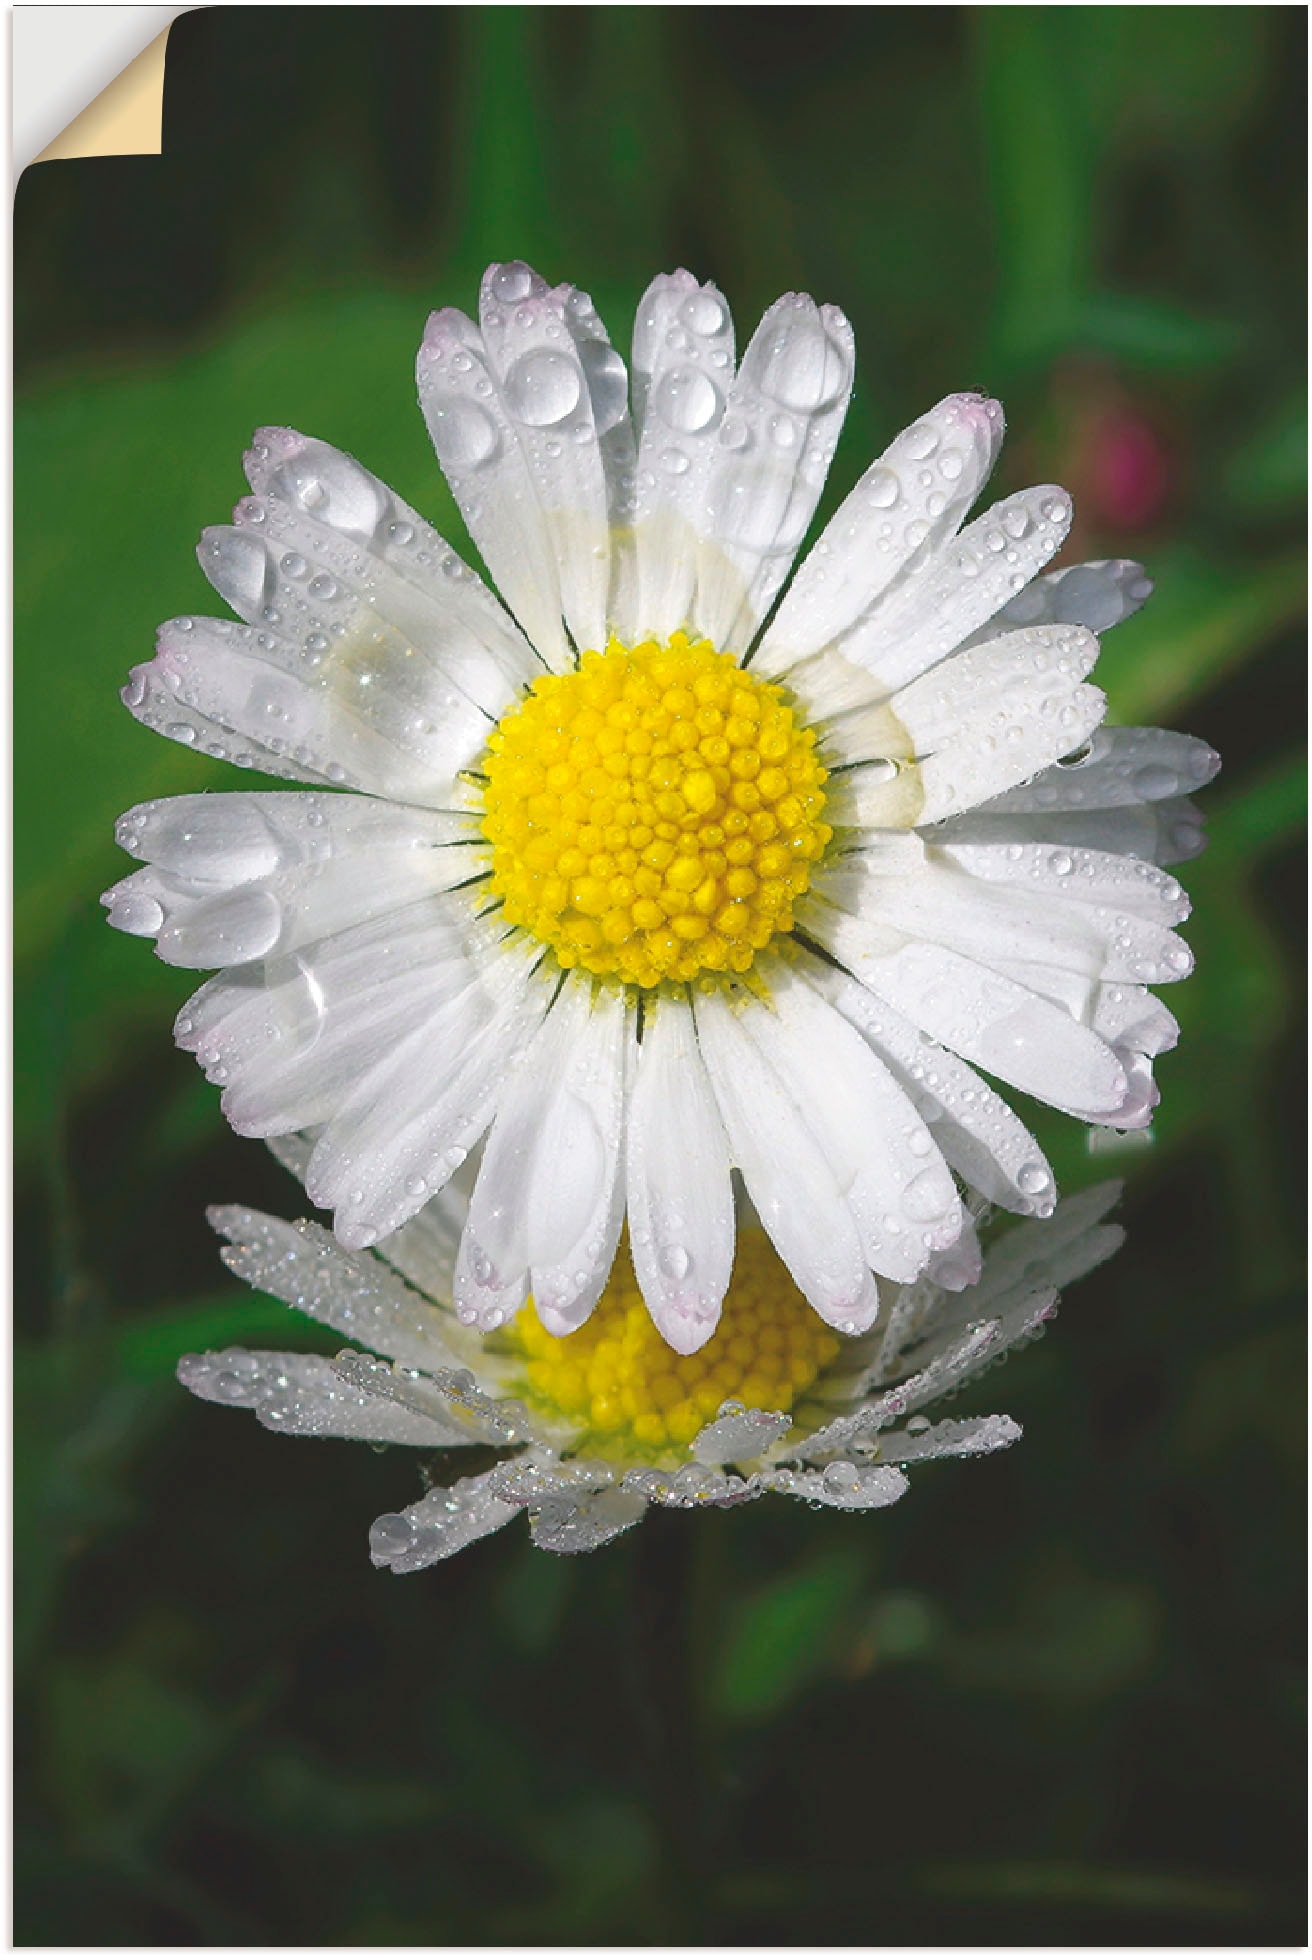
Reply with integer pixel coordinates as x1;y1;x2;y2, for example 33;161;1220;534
1094;545;1306;725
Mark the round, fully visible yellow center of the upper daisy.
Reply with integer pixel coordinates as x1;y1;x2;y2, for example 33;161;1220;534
482;633;832;988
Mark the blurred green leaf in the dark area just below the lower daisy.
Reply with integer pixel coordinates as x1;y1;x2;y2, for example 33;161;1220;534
710;1548;865;1723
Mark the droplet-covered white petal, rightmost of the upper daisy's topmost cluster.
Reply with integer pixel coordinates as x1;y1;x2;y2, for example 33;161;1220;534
692;294;855;653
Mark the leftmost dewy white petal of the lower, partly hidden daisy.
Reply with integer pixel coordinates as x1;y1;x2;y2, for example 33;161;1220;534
178;1348;451;1448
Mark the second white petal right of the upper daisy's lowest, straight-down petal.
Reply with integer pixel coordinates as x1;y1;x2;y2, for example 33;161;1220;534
757;960;961;1280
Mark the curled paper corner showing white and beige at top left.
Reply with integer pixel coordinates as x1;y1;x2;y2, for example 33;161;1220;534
12;6;192;174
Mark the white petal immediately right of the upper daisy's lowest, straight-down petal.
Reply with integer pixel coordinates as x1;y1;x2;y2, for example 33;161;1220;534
694;994;879;1333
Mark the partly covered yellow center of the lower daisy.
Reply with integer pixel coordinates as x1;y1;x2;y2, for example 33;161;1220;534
512;1229;839;1456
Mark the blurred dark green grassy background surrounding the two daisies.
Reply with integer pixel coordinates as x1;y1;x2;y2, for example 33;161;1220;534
14;6;1306;1946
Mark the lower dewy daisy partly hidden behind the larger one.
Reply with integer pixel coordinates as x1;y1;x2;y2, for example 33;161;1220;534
178;1141;1124;1572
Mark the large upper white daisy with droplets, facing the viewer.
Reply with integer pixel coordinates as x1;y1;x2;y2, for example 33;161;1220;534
106;265;1216;1352
